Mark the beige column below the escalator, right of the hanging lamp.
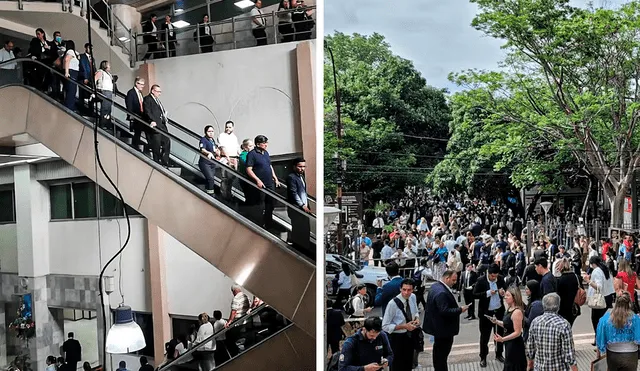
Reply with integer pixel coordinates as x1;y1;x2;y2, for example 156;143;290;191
147;220;172;366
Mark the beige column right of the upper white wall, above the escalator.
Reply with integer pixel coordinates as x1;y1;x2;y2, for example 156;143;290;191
296;41;316;201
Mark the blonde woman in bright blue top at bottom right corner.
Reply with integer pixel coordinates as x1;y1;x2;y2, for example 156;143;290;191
596;292;640;371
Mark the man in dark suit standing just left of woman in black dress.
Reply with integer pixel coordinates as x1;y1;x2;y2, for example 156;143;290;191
473;264;507;367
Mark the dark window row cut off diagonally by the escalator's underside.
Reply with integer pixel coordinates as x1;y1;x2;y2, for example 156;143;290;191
49;181;140;219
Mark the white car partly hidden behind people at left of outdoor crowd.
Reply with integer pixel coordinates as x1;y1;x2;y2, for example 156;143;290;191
325;254;388;306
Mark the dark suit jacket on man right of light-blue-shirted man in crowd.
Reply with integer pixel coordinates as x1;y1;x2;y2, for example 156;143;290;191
422;281;462;338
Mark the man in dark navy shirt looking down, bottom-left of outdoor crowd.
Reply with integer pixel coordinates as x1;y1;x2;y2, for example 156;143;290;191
338;317;393;371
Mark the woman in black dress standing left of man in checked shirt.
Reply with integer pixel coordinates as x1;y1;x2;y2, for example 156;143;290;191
492;286;527;371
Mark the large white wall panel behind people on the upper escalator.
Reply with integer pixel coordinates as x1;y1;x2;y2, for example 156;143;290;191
152;43;302;155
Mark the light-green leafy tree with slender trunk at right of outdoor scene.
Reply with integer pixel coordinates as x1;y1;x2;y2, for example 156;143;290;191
442;0;640;226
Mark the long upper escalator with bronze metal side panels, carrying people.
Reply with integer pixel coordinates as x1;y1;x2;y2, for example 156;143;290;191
0;59;316;370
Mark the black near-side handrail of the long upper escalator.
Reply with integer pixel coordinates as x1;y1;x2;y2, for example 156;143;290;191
0;58;316;220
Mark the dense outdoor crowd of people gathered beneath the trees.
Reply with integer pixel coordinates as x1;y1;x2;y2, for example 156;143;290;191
327;192;640;371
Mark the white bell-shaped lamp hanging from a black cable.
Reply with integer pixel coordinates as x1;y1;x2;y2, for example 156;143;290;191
106;305;147;354
